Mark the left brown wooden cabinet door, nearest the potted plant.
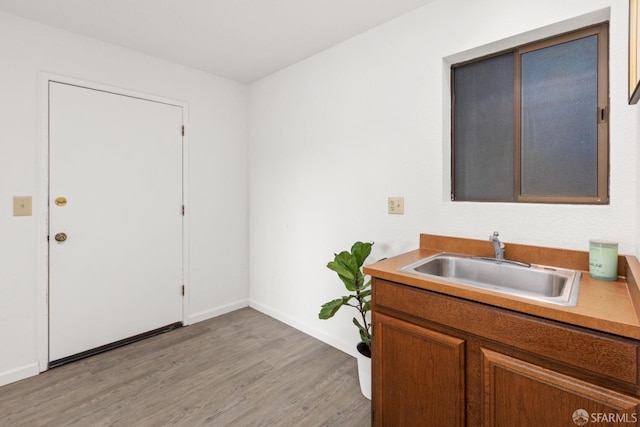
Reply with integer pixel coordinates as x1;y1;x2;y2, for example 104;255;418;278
372;313;465;427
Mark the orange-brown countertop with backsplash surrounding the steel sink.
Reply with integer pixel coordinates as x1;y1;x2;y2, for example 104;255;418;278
364;234;640;339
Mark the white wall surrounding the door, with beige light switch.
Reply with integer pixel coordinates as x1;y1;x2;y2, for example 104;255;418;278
0;13;249;385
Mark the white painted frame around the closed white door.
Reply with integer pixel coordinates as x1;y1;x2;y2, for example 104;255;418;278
34;72;190;372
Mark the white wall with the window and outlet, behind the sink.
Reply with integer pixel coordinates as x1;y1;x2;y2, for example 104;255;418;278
249;0;640;354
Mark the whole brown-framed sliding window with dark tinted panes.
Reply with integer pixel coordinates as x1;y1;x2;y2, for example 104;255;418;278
451;23;609;204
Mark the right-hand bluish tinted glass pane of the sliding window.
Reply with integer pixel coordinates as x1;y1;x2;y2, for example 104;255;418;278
520;35;598;196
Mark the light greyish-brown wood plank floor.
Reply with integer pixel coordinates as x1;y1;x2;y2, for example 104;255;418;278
0;308;371;427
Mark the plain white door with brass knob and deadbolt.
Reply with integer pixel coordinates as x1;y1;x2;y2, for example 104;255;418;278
49;82;183;361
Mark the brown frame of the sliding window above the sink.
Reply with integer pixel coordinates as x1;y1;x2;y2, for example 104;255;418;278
451;22;609;204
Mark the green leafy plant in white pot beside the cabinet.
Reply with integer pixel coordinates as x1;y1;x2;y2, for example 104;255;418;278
318;242;373;399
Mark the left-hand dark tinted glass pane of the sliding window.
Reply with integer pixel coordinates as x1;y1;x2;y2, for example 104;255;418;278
453;53;514;201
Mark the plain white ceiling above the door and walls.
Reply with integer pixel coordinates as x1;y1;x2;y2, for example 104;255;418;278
0;0;435;83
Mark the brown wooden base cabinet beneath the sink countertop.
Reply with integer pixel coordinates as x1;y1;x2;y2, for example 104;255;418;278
372;278;640;427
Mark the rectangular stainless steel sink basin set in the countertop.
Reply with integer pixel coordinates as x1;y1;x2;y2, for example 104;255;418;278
399;252;581;306
